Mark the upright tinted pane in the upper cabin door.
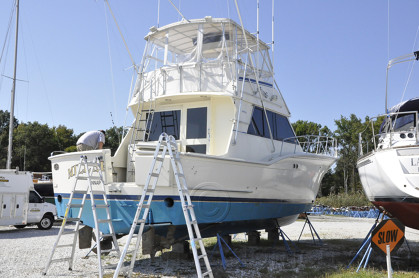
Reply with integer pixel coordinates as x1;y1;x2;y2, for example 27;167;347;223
186;107;207;139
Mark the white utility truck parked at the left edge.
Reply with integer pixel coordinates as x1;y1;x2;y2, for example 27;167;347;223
0;169;57;230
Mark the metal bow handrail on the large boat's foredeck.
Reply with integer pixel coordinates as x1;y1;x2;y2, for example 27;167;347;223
280;135;338;157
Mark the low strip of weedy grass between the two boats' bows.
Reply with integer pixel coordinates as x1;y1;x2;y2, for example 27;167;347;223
315;191;372;208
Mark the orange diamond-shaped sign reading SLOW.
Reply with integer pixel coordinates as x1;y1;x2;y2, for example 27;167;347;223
371;218;404;254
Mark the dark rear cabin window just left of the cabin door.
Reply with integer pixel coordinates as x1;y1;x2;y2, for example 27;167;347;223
147;110;180;141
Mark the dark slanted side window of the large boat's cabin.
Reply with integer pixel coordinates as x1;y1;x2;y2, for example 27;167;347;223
247;106;296;143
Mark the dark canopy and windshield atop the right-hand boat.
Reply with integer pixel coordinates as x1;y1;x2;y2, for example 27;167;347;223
380;97;419;133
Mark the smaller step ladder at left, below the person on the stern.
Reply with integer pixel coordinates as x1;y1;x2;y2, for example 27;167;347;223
43;156;120;278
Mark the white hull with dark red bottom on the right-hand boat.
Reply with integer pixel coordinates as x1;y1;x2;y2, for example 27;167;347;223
357;147;419;229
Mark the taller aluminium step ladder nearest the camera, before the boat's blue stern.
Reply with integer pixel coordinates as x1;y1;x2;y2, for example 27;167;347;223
113;133;214;278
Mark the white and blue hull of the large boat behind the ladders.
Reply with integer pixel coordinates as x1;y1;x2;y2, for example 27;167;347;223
50;151;335;238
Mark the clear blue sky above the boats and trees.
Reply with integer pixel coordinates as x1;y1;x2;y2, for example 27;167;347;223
0;0;419;135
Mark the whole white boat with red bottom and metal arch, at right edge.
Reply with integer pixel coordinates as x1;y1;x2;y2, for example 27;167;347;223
357;51;419;229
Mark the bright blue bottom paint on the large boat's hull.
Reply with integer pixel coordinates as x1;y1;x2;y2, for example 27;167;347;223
55;193;312;237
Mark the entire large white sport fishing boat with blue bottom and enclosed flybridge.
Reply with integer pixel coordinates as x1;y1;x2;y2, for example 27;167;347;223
49;17;337;250
